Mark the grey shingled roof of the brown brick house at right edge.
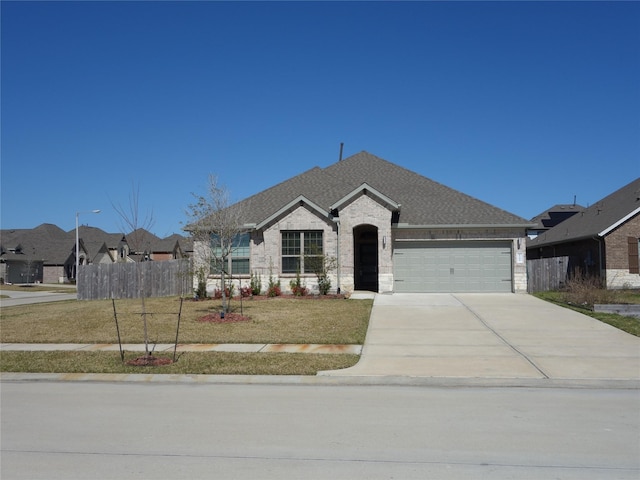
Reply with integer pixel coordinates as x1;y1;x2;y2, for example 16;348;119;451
527;178;640;248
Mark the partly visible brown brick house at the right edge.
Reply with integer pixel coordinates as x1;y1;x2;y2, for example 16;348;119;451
527;178;640;288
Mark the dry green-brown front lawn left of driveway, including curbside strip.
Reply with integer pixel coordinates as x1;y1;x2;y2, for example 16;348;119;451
0;297;373;375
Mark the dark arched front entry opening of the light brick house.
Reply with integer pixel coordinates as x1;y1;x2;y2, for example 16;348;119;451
353;225;378;292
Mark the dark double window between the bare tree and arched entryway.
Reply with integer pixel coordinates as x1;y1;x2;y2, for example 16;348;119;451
282;230;323;273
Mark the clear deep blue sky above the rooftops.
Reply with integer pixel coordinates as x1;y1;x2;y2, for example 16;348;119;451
0;1;640;237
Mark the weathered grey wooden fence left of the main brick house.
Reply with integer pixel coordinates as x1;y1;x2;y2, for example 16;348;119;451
78;259;193;300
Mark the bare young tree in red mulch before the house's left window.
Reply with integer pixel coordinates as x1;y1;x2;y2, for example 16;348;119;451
186;175;246;313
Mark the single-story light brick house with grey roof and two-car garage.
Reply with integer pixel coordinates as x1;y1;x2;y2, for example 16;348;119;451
194;152;533;292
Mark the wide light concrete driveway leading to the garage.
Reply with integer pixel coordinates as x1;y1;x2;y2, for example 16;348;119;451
320;293;640;388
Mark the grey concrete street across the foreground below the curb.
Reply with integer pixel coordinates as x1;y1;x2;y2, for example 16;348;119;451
1;382;640;480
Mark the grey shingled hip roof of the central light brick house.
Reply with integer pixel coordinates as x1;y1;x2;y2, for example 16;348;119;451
233;151;530;227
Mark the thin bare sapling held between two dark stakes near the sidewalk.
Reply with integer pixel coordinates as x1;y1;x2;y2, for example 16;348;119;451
112;185;154;357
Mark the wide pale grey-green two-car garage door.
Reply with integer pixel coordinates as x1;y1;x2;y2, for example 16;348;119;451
393;241;512;293
